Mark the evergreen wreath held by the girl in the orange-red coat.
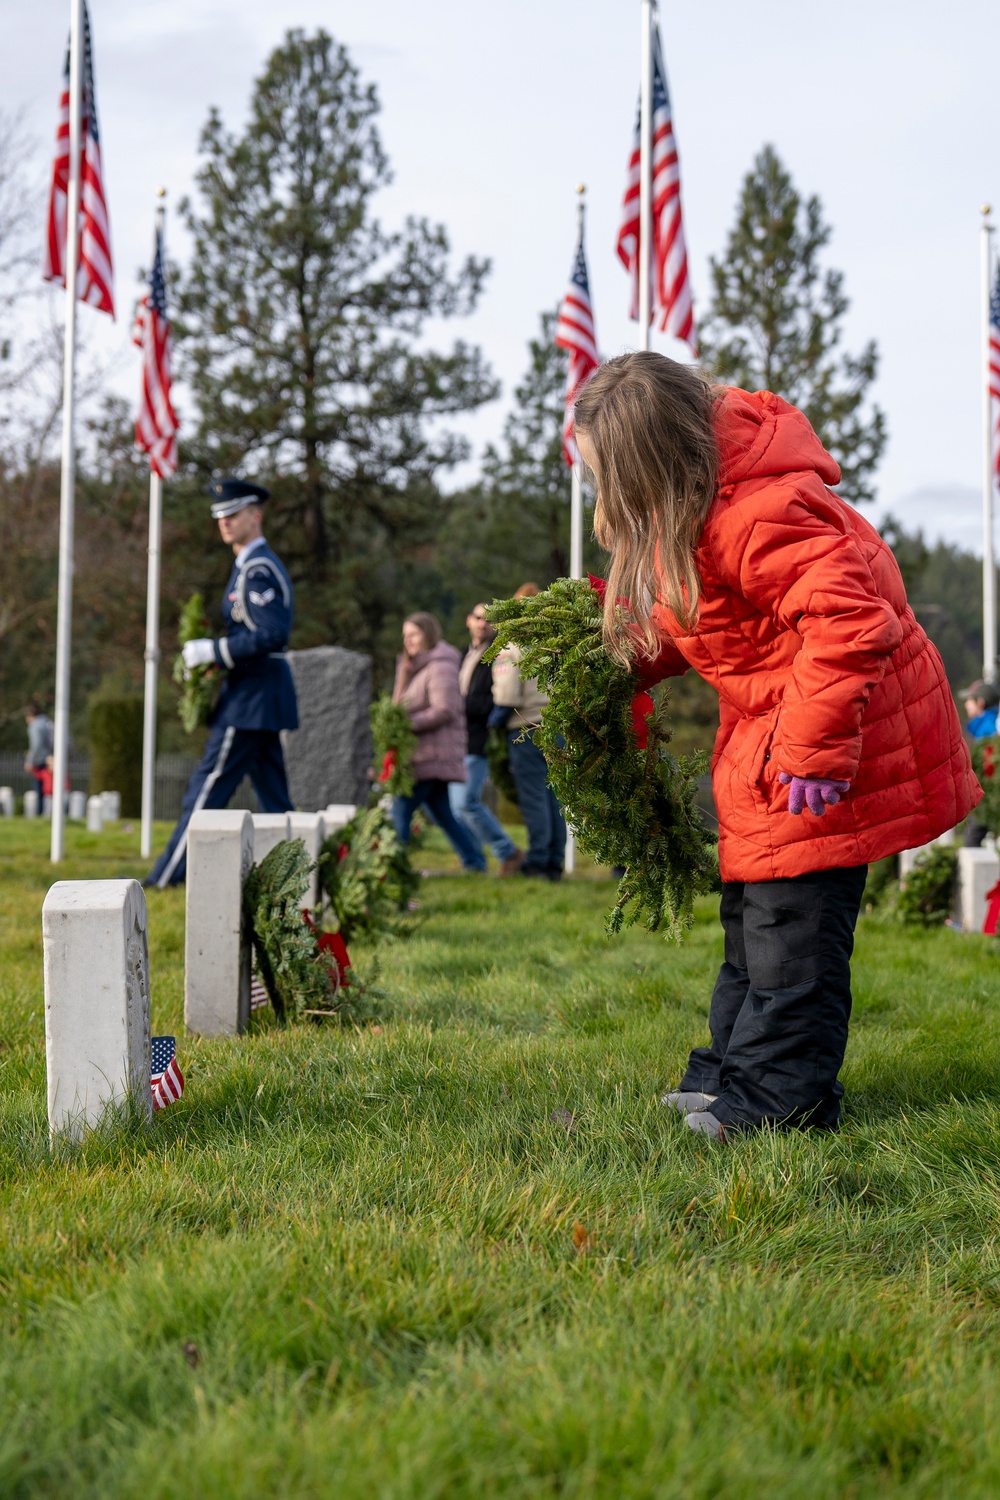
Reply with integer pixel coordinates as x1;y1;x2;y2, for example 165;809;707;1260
486;579;718;939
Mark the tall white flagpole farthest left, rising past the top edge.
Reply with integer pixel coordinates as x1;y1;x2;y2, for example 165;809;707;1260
49;0;84;864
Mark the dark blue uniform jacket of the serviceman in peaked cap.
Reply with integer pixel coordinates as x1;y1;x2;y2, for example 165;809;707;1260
211;542;298;729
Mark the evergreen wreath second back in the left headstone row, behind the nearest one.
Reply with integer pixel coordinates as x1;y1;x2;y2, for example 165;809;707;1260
318;806;420;947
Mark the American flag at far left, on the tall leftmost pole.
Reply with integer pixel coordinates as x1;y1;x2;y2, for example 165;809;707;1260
42;5;114;318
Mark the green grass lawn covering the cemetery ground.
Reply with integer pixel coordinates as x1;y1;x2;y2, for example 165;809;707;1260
0;821;1000;1500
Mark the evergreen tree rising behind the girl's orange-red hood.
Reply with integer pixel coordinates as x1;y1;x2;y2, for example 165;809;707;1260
699;146;886;501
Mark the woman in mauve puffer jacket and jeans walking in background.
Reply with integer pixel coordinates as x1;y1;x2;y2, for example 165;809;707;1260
393;612;486;872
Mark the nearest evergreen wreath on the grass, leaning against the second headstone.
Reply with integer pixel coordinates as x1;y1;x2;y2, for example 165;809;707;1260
243;839;373;1022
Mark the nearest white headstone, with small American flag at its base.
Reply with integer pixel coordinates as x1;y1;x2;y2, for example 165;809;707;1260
42;881;153;1140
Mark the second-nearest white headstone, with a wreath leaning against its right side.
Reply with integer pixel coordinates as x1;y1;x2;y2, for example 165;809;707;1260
184;809;253;1037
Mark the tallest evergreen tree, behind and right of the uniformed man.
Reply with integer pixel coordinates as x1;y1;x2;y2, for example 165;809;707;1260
177;30;496;663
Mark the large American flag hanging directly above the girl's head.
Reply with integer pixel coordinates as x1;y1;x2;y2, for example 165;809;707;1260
618;24;697;354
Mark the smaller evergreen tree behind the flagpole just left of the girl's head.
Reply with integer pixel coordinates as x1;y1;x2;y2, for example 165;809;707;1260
439;312;604;620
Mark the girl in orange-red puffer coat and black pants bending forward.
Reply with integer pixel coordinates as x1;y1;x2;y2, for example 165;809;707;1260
576;354;982;1139
